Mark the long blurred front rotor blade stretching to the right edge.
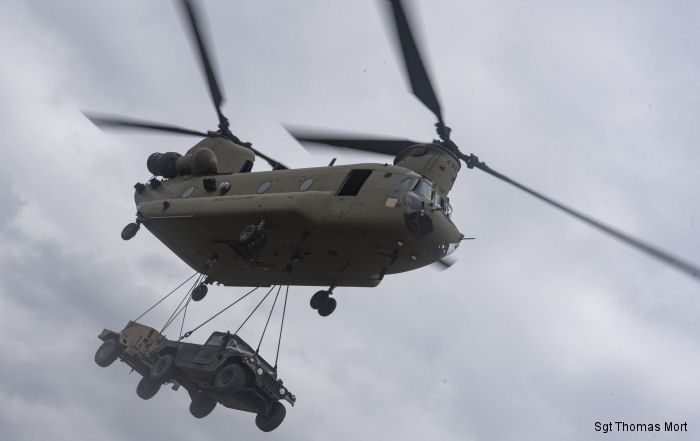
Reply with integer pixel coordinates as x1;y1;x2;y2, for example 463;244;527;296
474;162;700;278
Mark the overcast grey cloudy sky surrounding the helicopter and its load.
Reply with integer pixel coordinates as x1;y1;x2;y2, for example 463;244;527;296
0;0;700;440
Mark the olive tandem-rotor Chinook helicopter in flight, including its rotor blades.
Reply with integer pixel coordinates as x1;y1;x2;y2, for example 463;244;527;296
87;0;700;316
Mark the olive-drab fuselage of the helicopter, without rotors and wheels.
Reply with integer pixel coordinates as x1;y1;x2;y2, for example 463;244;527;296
135;139;463;287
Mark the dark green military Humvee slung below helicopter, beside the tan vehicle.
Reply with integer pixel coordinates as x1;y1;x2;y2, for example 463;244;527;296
149;332;296;432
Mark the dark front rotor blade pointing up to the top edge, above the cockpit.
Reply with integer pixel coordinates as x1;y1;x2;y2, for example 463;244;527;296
389;0;443;124
